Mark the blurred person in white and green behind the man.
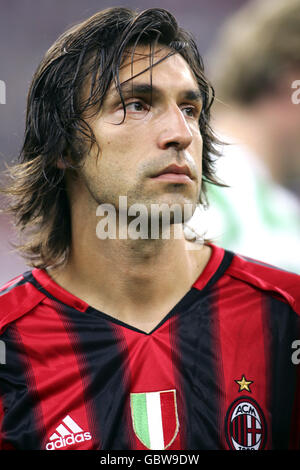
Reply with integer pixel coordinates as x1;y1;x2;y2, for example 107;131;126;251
190;0;300;273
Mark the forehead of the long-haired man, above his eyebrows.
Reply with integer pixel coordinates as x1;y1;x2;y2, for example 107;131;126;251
112;45;199;89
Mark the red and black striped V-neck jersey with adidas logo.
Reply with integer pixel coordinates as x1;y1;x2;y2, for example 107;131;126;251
0;245;300;450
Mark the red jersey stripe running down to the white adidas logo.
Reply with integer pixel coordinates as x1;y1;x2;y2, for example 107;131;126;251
14;299;93;450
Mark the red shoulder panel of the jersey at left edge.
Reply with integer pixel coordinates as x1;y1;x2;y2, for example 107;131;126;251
0;271;45;333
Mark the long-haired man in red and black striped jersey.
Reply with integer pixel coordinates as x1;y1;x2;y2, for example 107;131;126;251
0;8;300;450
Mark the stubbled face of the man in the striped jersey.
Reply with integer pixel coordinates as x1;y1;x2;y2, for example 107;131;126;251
77;46;202;218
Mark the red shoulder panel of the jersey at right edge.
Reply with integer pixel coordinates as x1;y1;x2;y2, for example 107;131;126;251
226;253;300;314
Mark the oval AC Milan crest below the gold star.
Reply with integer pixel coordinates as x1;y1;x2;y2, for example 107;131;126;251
225;397;267;450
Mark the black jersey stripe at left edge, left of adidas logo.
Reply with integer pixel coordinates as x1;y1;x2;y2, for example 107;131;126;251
0;325;44;450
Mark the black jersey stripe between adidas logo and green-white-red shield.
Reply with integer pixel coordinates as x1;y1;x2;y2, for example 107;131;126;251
56;303;131;450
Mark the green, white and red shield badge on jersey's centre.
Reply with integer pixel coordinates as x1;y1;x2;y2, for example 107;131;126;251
130;390;179;450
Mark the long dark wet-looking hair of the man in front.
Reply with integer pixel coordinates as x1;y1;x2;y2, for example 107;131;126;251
3;8;222;268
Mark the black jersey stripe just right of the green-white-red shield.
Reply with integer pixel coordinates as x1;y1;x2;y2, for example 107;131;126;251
172;289;221;450
